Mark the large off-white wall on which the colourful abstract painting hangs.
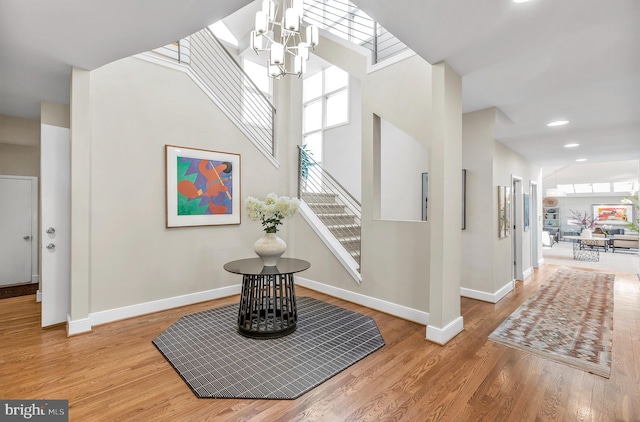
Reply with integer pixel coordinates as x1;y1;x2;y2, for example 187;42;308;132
84;58;289;312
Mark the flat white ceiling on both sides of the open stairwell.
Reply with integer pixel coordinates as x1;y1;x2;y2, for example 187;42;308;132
0;0;640;177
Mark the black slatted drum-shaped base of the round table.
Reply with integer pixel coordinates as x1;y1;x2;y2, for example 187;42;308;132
238;274;298;338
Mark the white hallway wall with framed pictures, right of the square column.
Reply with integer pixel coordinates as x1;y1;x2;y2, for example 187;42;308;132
461;108;541;301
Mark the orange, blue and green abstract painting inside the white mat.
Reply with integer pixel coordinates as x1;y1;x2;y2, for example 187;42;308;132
177;156;233;215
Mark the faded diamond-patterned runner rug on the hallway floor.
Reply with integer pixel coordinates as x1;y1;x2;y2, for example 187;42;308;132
489;268;615;378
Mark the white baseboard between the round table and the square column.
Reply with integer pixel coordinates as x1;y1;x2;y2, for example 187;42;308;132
295;276;429;325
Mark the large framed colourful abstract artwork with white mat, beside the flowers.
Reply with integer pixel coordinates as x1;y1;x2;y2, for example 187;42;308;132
165;145;241;228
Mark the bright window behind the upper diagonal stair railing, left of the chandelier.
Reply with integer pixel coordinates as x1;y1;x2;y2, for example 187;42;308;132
242;59;273;127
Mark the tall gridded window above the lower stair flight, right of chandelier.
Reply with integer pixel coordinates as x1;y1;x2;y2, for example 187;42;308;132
302;66;349;163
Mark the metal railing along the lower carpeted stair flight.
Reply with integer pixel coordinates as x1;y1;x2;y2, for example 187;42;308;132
298;146;362;262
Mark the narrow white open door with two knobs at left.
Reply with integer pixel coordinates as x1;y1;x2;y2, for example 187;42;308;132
40;125;71;327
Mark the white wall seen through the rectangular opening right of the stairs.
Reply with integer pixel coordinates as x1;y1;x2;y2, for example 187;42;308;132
380;119;429;221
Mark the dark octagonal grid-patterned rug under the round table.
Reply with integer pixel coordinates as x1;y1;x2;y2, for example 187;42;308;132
153;297;384;399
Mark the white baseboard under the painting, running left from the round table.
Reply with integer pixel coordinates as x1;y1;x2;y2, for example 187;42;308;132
67;284;241;335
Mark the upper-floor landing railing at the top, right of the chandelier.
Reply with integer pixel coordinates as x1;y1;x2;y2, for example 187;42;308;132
304;0;409;64
